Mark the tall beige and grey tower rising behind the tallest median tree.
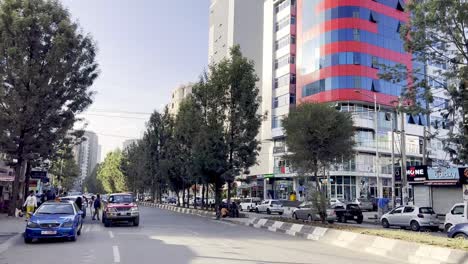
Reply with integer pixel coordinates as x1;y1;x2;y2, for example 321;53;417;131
208;0;266;187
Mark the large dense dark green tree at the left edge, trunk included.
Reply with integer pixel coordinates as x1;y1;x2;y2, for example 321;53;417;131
0;0;98;214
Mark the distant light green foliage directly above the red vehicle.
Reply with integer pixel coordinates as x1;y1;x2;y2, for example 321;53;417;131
97;150;128;193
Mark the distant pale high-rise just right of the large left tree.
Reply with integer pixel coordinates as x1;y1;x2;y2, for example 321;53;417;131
75;131;99;180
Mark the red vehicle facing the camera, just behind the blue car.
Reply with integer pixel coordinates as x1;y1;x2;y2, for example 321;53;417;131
102;193;140;227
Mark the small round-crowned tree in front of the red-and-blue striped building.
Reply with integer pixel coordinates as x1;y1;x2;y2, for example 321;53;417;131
282;103;355;221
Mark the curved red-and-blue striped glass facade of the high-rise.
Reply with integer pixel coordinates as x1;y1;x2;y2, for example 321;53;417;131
296;0;412;106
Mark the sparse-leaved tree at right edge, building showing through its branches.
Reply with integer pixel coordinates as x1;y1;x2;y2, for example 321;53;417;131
381;0;468;164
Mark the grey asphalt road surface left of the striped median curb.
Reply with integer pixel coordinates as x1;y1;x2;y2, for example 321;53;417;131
0;207;402;264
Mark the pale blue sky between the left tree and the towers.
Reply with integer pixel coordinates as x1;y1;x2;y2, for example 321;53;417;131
61;0;209;160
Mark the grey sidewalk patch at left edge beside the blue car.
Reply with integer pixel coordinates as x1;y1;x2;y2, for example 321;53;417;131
0;214;26;254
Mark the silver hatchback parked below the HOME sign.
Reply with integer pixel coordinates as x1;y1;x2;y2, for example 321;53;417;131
380;205;439;231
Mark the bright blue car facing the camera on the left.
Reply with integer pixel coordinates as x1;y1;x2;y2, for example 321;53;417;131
24;201;83;243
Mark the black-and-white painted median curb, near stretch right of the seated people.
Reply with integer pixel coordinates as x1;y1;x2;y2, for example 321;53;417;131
228;218;468;264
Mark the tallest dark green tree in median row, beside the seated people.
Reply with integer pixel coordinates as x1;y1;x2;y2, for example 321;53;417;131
220;45;262;201
